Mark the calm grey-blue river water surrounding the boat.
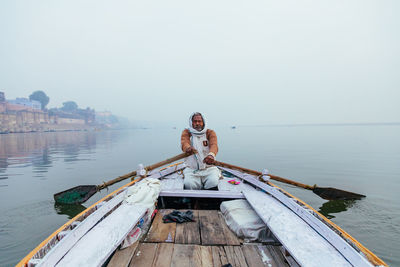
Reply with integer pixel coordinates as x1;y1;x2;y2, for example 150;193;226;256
0;125;400;266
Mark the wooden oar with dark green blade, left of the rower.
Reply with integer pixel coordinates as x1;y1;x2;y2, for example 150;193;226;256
54;153;189;204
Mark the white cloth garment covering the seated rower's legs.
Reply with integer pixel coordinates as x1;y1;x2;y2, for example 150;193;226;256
183;166;221;190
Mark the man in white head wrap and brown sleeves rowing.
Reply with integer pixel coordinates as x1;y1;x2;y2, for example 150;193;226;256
181;112;220;190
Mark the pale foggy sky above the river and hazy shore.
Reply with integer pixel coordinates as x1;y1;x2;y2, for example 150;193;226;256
0;0;400;126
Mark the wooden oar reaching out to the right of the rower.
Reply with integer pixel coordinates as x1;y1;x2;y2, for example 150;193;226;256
214;161;365;200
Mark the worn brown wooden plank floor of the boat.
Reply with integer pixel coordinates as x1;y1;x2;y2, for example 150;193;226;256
108;209;298;267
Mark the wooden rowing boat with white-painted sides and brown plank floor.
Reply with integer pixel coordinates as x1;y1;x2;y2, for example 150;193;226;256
17;158;387;266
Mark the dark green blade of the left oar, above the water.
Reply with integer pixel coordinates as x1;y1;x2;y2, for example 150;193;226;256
54;185;97;204
